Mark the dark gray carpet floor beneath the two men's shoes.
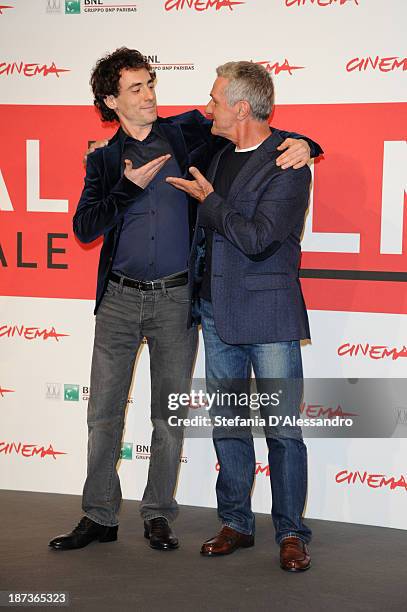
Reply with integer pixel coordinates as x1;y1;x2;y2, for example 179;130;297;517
0;491;407;612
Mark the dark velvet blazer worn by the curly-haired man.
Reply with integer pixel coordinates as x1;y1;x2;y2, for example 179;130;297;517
73;110;321;313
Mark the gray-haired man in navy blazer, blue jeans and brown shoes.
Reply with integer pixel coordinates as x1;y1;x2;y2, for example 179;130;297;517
167;61;320;572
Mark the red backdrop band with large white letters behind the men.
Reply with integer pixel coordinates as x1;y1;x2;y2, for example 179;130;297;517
0;103;407;313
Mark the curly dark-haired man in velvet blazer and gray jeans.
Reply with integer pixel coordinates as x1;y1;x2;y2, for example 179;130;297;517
50;47;320;550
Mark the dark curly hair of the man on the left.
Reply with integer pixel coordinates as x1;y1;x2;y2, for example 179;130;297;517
90;47;155;121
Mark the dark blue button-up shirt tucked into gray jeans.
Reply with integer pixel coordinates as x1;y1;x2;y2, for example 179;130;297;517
112;123;190;280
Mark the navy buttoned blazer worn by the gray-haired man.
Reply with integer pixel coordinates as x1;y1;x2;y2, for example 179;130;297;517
191;130;311;344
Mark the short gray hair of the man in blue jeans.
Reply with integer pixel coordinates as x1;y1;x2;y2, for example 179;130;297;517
216;61;274;121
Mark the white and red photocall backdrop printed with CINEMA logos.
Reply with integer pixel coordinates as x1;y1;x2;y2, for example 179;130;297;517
0;0;407;528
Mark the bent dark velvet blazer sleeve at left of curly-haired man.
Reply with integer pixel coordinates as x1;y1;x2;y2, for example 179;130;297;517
73;155;144;242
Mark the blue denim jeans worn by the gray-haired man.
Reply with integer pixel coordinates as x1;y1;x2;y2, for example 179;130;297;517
201;300;311;544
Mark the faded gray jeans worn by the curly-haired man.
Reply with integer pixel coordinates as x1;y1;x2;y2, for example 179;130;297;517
82;281;198;526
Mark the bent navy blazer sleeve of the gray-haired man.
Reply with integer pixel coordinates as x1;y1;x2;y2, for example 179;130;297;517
198;166;311;261
